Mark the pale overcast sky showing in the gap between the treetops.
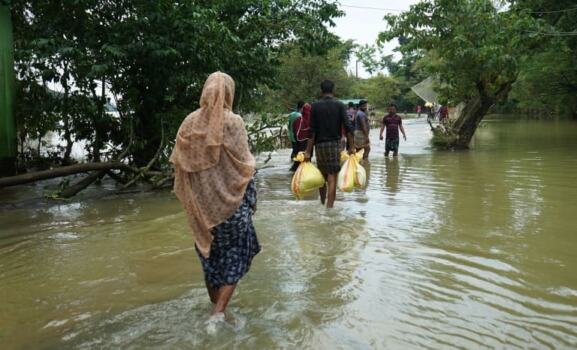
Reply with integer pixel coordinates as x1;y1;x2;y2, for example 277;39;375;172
331;0;419;78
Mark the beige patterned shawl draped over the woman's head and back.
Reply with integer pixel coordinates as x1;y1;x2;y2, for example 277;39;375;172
170;72;255;257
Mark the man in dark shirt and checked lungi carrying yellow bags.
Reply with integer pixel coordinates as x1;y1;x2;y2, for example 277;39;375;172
305;80;355;208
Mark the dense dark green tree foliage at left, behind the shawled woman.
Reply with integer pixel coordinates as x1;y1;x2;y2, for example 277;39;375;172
12;0;342;166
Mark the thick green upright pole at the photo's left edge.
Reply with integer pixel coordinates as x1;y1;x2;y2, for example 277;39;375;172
0;0;17;176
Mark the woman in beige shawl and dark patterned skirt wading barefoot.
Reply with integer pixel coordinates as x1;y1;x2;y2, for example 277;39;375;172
170;72;260;315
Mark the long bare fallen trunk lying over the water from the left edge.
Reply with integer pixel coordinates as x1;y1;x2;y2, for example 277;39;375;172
0;162;135;188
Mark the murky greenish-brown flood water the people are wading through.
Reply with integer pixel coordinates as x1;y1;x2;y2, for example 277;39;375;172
0;120;577;349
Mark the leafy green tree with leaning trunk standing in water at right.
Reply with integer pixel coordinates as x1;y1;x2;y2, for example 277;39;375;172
380;0;540;148
